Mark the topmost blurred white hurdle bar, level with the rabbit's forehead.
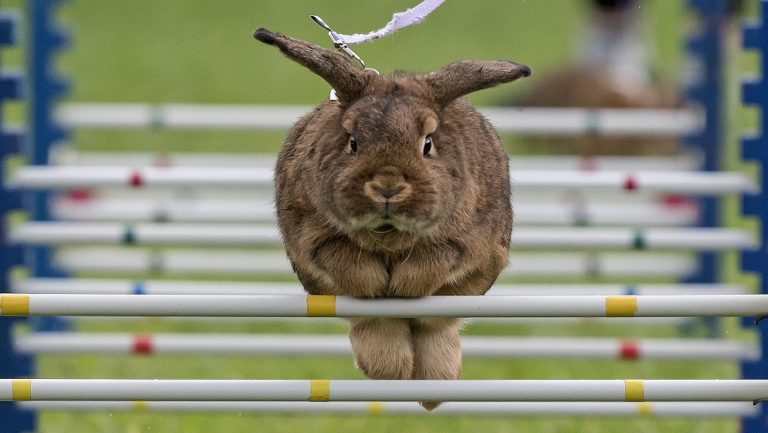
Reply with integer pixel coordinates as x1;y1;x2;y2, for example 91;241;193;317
56;102;704;136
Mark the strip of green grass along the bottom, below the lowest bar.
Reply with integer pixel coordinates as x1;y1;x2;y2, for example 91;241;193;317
34;413;737;433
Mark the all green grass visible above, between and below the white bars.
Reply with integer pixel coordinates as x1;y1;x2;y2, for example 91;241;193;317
6;0;751;433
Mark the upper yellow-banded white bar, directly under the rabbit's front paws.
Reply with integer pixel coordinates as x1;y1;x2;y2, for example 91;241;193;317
0;294;768;318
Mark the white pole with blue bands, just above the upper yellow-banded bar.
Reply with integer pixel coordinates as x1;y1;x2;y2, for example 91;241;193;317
10;278;748;296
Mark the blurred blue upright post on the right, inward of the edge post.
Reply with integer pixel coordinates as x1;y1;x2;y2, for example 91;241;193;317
685;0;728;335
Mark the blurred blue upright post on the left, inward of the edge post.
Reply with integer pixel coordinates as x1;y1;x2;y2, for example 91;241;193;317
25;0;68;331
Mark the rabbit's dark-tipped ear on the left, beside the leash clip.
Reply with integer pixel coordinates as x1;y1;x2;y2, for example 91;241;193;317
253;28;370;101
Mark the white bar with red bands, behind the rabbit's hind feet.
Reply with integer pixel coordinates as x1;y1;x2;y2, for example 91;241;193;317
14;332;760;362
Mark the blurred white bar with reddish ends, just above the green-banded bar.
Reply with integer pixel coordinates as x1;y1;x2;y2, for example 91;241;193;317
51;196;699;227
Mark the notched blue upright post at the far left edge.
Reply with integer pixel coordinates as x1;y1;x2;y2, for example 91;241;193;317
0;6;36;433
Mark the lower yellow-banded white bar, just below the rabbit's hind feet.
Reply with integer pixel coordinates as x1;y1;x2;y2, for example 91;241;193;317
0;379;768;402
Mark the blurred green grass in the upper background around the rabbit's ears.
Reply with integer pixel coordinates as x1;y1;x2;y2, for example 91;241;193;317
61;0;685;151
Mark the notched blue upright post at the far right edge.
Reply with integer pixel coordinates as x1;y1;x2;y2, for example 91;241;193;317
741;0;768;433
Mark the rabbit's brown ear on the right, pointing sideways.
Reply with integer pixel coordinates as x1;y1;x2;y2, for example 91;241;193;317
424;61;531;106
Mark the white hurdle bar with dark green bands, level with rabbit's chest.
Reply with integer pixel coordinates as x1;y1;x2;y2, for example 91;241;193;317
9;222;757;251
